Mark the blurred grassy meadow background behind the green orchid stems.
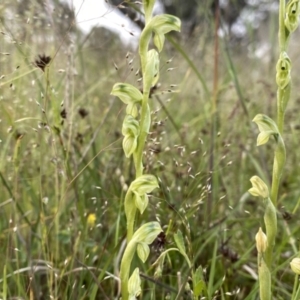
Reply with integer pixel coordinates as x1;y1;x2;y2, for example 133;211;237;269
0;0;300;299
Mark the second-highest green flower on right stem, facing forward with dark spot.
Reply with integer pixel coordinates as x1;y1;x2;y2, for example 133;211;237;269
276;52;291;90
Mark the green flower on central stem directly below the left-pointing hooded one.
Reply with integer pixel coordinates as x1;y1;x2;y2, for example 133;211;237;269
122;115;140;157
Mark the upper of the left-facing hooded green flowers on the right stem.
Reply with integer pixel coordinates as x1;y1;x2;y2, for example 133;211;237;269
253;114;279;146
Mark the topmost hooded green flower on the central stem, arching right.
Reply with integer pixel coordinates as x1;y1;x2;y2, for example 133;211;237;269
148;14;181;52
